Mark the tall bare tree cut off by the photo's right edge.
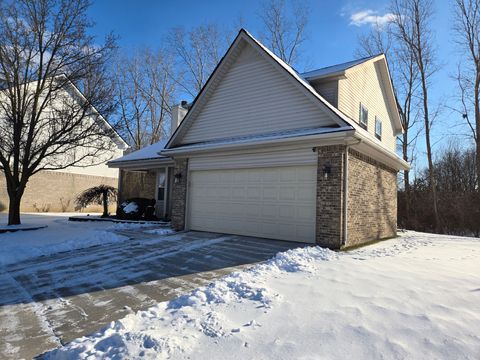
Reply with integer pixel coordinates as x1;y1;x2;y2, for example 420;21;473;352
454;0;480;191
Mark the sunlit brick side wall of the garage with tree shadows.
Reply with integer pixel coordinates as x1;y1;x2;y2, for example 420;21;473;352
346;149;397;246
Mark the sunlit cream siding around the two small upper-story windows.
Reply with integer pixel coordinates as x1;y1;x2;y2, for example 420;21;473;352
338;61;396;152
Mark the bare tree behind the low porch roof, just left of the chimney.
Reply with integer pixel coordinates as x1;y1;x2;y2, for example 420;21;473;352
115;49;176;149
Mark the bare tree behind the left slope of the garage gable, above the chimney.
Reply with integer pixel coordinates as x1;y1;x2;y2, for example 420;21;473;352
167;23;231;98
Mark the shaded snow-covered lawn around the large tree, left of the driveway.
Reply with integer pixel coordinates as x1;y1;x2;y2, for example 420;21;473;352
0;213;166;266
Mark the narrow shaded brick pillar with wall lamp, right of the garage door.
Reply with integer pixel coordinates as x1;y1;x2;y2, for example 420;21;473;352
316;145;345;249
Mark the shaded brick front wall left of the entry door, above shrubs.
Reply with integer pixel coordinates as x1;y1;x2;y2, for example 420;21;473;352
118;170;157;202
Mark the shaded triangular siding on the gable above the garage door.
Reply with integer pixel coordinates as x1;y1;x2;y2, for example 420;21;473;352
182;46;334;144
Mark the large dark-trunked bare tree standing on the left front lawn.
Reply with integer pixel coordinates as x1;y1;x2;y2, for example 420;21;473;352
0;0;115;224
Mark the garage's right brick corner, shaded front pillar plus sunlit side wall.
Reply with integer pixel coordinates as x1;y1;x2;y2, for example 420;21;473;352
316;145;397;249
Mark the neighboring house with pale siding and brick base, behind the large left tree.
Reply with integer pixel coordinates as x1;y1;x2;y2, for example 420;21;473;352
0;78;128;212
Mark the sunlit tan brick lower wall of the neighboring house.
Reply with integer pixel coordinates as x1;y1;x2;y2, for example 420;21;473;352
0;171;118;212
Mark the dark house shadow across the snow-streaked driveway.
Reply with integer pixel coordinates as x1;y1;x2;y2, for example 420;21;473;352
0;232;306;307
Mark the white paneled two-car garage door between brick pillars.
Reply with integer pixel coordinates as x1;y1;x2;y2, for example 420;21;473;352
189;166;317;243
